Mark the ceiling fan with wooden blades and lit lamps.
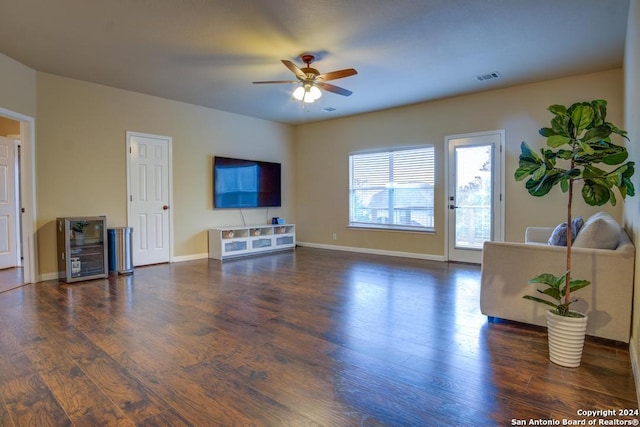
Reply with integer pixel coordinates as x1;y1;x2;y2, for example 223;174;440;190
253;54;358;102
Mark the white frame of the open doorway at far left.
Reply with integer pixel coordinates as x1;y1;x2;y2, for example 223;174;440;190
0;107;40;283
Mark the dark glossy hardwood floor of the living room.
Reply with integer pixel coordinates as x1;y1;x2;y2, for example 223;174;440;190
0;248;638;426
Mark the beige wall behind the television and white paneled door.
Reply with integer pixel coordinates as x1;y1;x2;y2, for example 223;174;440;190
36;73;295;277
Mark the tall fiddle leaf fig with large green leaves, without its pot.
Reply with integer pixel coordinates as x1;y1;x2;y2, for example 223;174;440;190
514;99;635;317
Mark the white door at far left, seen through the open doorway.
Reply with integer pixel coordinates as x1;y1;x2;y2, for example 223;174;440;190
0;136;20;268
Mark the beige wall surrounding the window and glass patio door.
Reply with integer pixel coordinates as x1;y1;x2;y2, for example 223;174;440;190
295;69;623;256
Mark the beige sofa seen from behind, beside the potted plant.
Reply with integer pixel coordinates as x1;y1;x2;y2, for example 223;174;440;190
480;216;635;342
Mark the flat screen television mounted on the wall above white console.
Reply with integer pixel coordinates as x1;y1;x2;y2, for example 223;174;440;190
213;156;282;208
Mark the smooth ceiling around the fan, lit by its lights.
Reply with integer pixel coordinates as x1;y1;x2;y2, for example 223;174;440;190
0;0;629;124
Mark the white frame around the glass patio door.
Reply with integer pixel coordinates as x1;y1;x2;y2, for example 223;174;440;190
444;129;506;261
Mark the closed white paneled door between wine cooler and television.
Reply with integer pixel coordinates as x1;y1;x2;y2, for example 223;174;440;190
127;132;171;266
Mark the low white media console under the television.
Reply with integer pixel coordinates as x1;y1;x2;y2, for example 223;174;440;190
209;224;296;260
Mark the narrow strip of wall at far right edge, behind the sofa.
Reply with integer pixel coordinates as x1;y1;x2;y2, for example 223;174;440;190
624;0;640;402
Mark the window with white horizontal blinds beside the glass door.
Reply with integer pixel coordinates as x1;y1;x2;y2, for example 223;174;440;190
349;145;435;231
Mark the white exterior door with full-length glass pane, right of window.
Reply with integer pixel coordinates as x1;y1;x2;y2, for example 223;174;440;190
446;130;504;264
